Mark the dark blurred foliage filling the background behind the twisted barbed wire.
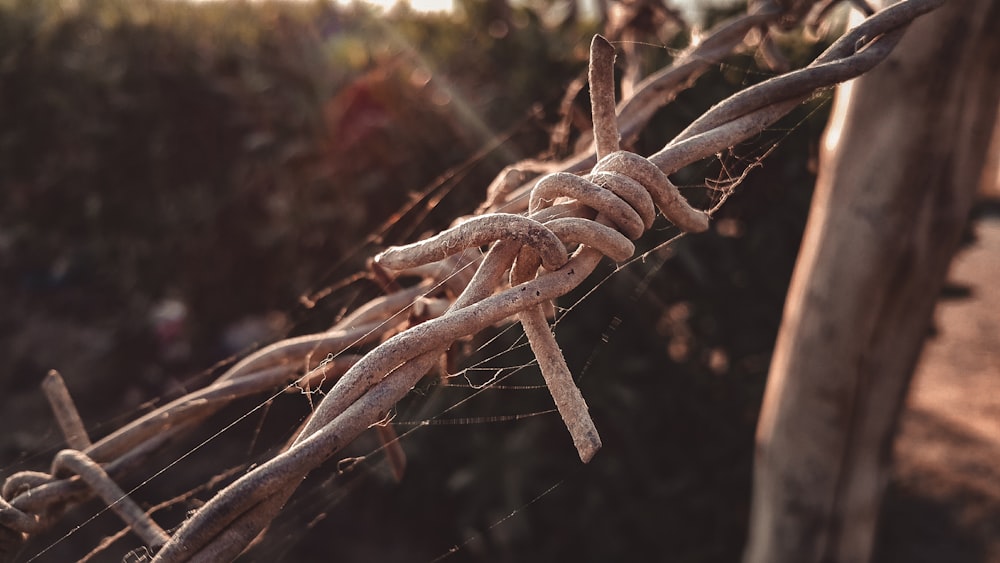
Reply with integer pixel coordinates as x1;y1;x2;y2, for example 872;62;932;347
0;0;826;562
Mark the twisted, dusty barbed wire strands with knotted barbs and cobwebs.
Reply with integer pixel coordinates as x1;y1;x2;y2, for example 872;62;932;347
0;0;944;562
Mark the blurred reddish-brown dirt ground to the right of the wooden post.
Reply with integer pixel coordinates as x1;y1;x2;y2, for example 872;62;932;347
876;213;1000;563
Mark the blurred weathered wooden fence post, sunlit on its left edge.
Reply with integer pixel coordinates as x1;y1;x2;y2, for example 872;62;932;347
745;0;1000;563
